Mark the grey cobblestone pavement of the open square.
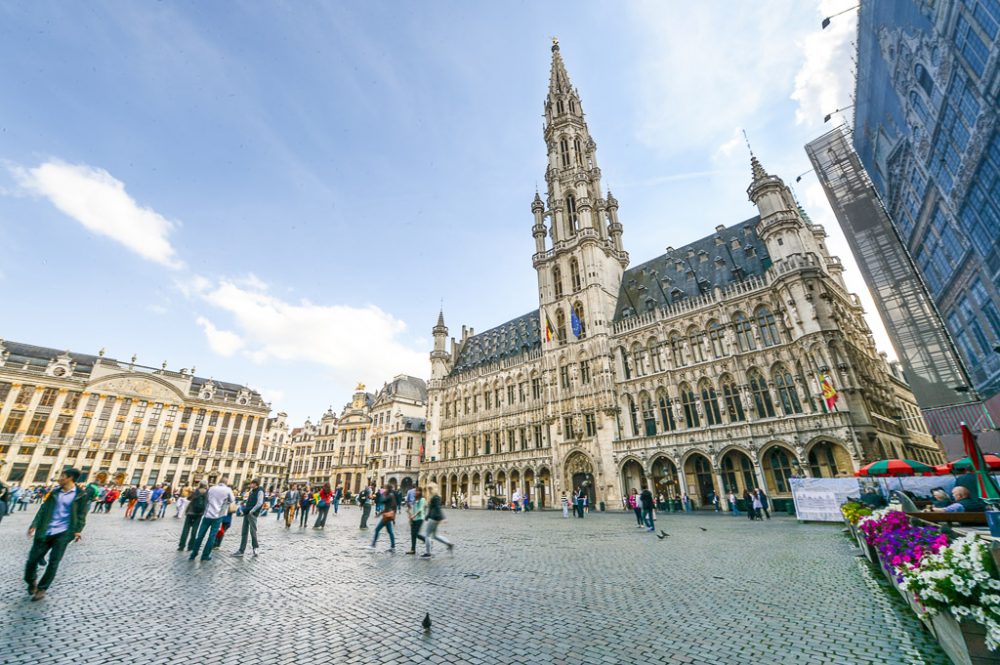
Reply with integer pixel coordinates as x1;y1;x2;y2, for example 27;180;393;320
0;508;947;665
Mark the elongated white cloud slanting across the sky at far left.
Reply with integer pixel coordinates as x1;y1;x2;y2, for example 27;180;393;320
11;160;183;268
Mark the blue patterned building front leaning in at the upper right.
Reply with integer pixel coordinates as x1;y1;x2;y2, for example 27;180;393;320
853;0;1000;400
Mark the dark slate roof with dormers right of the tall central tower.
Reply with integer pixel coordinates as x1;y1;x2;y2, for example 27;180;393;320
614;216;771;321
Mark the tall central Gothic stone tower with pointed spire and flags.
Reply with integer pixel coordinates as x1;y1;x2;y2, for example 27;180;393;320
531;40;629;508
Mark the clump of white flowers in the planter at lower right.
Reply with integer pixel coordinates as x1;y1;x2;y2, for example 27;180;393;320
900;535;1000;651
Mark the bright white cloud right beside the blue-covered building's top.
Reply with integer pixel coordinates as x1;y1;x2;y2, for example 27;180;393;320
792;0;857;127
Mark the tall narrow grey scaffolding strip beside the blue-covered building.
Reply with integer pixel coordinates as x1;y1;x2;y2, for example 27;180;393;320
806;126;976;434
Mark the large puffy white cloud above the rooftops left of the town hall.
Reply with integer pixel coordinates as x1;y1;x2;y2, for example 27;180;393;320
186;276;429;385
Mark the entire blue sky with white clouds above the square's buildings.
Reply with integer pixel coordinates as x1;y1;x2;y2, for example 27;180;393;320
0;0;880;423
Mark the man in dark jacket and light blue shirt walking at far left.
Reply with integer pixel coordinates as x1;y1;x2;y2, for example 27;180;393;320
24;468;90;600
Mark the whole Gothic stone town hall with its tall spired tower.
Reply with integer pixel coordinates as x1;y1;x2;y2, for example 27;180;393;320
420;43;943;507
